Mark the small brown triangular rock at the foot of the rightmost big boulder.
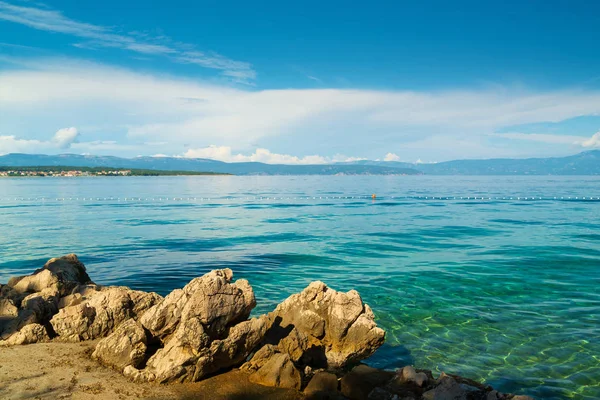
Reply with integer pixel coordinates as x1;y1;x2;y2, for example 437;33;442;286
248;353;302;390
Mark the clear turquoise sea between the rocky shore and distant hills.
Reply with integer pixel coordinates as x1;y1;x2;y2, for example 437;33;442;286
0;176;600;399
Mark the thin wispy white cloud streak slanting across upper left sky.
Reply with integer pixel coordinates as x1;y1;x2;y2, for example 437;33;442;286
0;1;256;84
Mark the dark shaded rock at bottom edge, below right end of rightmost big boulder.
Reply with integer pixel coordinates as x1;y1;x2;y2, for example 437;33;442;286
341;365;394;400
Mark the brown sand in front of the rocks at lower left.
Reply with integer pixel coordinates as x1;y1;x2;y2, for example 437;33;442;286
0;341;303;400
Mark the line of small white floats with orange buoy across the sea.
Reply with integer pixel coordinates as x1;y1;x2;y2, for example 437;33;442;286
0;194;600;204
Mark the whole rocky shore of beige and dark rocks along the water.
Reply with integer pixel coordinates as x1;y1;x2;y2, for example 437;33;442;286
0;254;529;400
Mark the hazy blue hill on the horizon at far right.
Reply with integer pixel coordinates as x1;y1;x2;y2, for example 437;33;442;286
343;150;600;175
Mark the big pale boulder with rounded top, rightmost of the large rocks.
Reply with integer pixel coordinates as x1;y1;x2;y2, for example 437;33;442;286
269;282;385;368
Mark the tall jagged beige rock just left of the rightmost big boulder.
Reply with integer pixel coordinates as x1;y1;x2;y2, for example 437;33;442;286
119;269;260;382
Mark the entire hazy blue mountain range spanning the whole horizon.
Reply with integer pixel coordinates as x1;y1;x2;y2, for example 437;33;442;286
0;150;600;175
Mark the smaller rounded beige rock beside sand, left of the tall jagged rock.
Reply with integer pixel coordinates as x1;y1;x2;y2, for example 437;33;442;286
92;319;147;372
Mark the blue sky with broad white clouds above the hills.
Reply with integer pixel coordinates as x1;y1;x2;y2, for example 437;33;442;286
0;0;600;164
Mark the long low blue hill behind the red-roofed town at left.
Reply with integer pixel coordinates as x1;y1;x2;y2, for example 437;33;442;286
0;153;422;175
